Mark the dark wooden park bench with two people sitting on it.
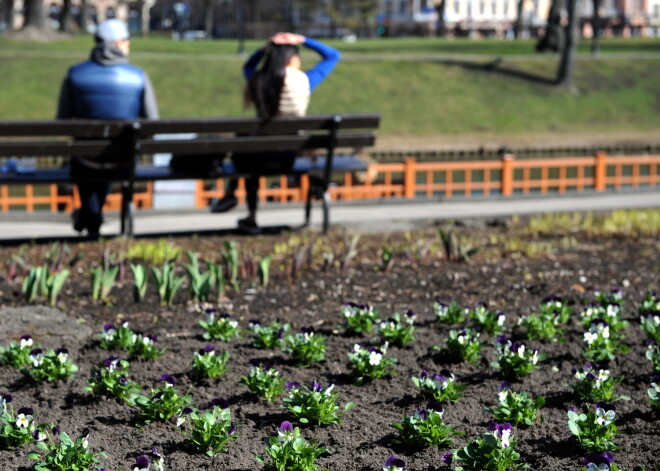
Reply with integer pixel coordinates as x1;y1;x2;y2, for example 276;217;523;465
0;114;380;236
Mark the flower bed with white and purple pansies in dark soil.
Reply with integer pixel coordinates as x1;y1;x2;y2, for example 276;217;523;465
0;229;659;471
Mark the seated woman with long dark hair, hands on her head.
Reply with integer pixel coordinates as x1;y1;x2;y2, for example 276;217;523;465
211;33;341;234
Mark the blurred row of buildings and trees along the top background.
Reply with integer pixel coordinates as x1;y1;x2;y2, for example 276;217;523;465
0;0;660;40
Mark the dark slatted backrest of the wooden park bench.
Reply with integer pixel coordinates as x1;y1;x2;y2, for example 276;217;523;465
0;114;380;160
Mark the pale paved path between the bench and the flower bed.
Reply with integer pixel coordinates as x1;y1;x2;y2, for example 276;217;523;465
0;189;660;244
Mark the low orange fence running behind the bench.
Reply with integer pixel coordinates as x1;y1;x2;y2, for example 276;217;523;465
0;152;660;212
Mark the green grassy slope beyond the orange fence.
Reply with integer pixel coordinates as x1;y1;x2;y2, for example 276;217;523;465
0;37;660;136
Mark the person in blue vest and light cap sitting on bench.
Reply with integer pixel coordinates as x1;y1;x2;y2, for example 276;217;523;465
57;19;158;237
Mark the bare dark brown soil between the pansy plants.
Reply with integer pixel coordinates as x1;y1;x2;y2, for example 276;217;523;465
0;227;660;471
